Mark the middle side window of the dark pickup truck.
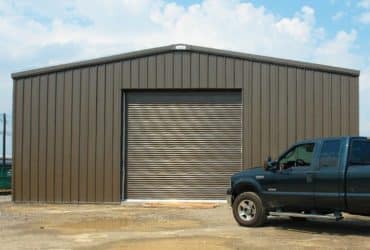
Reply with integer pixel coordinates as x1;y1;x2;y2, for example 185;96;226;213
320;140;341;168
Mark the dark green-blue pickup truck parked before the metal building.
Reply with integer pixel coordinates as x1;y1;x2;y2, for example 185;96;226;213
227;137;370;227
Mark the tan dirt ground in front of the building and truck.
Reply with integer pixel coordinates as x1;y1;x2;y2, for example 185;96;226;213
0;198;370;250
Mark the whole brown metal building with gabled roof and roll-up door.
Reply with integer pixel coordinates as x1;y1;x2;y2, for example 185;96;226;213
12;45;359;203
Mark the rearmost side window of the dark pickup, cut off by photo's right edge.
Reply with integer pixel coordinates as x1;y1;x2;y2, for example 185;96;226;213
349;140;370;165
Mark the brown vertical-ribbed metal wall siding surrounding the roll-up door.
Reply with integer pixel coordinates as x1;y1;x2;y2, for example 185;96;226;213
14;51;359;202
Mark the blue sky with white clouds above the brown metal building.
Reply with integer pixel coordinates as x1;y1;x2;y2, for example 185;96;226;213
0;0;370;154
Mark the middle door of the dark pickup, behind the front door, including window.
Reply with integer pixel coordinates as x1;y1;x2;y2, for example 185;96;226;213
313;139;345;210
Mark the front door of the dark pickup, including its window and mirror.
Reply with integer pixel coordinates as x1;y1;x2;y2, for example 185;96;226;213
273;142;316;208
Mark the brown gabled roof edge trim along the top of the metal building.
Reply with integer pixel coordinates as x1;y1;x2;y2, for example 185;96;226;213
11;44;360;79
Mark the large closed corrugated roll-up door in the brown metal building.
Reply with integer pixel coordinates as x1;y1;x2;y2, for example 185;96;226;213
126;91;242;199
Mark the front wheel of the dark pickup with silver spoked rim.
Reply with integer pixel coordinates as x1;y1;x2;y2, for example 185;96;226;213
233;192;267;227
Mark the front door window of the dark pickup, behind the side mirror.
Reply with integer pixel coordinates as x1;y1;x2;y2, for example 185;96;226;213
279;143;315;169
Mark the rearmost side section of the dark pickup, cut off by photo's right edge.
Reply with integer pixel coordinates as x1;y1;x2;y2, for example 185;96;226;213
346;139;370;214
